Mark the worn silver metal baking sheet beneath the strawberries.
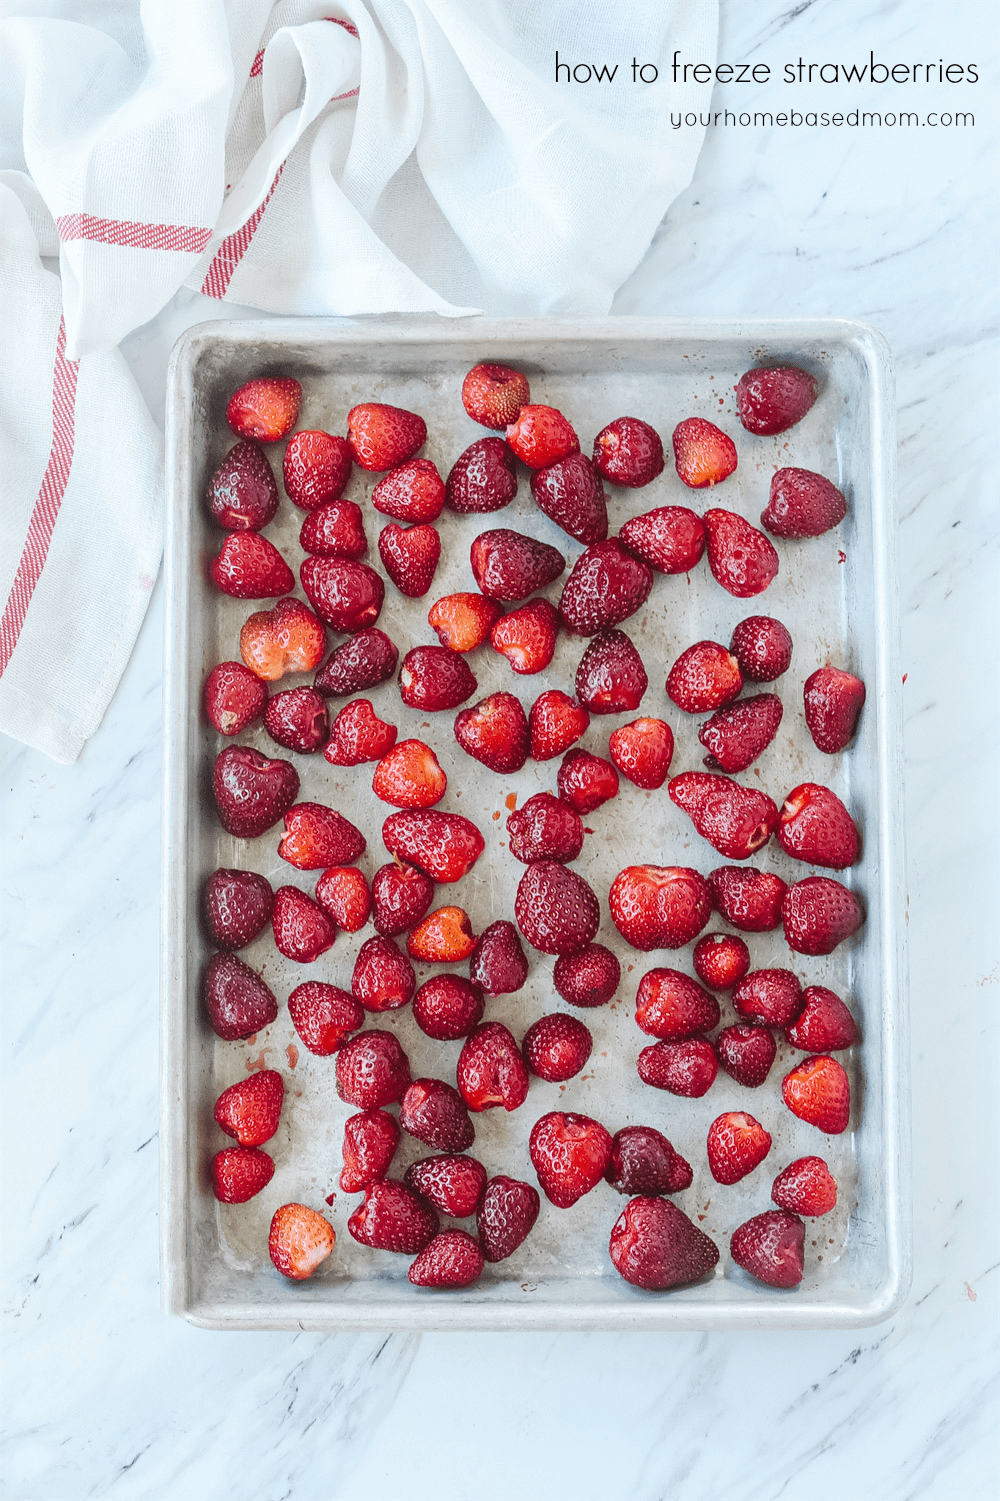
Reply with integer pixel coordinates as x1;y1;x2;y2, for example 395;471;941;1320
161;318;910;1330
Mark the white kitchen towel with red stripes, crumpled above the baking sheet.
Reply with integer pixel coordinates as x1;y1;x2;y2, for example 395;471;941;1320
0;0;718;761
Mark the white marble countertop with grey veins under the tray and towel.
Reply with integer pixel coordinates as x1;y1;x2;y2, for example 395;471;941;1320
2;0;997;1501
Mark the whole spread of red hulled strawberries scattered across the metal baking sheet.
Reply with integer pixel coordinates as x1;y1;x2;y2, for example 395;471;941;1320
203;363;865;1289
